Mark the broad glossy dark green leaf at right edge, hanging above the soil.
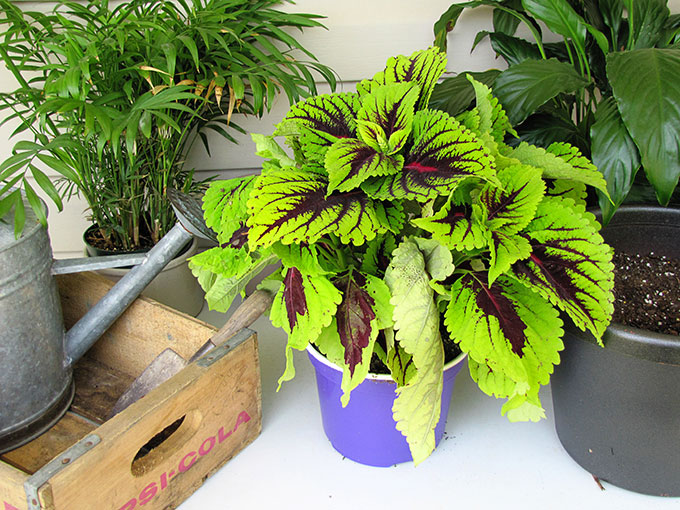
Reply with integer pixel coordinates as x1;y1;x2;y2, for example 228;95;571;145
607;48;680;205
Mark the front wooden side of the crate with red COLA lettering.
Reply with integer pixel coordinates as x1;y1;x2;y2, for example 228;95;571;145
41;335;262;510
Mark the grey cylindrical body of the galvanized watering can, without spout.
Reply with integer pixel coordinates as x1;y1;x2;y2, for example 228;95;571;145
0;214;73;451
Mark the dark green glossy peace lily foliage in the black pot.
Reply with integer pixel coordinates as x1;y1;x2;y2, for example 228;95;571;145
432;0;680;224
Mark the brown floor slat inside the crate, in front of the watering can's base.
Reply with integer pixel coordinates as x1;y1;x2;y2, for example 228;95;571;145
0;411;96;474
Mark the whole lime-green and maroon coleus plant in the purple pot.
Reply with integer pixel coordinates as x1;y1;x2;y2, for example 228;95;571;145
191;49;613;463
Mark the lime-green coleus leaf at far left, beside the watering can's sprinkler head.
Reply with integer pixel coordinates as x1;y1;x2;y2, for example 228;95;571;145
203;176;255;248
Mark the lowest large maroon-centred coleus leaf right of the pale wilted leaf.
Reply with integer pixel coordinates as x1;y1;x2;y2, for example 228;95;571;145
444;272;563;418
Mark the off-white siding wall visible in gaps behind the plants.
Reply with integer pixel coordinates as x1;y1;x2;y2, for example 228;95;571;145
0;0;500;257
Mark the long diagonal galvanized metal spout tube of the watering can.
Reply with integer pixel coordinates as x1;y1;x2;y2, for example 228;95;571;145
65;222;192;367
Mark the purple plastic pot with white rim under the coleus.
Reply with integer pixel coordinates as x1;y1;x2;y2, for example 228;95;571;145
307;345;465;467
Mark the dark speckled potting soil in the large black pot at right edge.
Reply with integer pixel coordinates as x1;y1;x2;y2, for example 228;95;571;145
613;252;680;335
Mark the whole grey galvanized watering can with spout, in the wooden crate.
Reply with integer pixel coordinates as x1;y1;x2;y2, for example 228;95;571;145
0;197;199;453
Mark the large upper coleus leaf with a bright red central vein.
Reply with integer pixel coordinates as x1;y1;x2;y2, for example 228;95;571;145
362;110;494;202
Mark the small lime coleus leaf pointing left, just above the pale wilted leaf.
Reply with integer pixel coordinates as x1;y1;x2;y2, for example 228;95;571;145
411;198;487;251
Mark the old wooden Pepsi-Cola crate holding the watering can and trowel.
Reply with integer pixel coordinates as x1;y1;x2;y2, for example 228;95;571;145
0;274;262;510
